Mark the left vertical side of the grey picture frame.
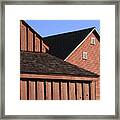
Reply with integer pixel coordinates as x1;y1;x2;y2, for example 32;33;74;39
0;2;5;118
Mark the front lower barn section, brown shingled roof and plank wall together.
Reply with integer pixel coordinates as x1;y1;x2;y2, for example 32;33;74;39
20;52;99;100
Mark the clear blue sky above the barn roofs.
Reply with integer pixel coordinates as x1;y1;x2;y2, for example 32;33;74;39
25;20;100;37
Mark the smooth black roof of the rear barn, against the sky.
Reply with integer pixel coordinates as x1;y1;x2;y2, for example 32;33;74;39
43;27;100;60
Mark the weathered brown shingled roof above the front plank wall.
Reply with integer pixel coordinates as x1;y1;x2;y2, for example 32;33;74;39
20;51;98;77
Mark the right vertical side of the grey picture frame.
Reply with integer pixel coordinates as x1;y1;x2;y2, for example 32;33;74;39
115;2;120;119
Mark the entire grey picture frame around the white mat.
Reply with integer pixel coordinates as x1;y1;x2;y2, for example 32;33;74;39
0;0;120;119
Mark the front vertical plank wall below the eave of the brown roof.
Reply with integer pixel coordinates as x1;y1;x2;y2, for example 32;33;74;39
20;79;96;100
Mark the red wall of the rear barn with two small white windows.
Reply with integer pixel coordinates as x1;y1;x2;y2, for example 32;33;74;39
66;33;100;99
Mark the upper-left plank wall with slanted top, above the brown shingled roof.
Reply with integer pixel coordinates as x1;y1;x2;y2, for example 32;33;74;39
20;20;49;52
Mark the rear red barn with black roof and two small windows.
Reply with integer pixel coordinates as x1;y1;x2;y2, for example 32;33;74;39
44;27;100;99
